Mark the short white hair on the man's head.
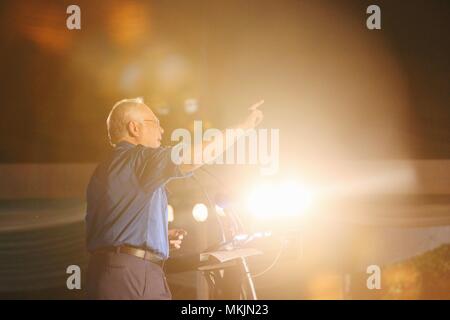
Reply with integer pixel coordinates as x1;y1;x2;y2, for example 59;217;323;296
106;97;144;147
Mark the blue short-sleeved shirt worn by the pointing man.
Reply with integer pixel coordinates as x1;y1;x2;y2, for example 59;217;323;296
86;141;188;258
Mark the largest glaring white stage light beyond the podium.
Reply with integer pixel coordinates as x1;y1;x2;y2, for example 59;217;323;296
248;182;313;218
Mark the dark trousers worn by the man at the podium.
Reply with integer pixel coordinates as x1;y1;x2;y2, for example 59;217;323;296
86;252;172;300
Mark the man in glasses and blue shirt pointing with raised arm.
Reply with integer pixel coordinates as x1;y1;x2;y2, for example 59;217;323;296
86;99;262;299
